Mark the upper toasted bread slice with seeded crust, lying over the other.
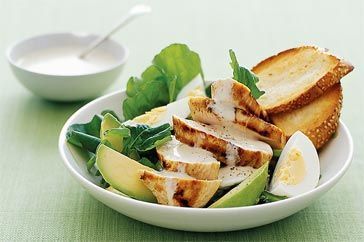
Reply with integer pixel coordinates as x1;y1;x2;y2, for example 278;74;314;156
252;46;354;114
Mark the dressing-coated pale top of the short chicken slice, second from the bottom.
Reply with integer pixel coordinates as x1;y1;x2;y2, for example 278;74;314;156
157;136;218;164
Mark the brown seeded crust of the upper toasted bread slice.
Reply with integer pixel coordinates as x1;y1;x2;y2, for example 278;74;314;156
252;46;354;114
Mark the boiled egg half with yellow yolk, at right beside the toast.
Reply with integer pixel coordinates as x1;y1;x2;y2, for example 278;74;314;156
270;131;320;197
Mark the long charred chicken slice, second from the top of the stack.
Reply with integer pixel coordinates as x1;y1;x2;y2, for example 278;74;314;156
189;97;286;149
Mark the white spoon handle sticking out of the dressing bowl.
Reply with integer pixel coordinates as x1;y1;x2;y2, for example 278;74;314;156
79;4;151;59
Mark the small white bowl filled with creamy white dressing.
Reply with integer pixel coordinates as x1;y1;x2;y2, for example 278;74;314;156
7;33;128;101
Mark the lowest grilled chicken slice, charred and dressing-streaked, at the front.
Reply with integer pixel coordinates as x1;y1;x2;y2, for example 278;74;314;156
140;170;221;208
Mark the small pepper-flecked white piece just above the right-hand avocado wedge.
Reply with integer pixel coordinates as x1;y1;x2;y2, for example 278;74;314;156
218;166;256;188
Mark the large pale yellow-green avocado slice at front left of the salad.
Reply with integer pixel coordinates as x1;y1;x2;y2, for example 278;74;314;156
96;144;156;202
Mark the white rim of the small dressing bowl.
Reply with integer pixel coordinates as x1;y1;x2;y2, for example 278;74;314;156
5;32;129;76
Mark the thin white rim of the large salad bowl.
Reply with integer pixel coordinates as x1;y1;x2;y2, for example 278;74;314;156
58;90;353;213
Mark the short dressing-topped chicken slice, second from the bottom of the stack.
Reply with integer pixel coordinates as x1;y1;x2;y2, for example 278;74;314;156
157;137;220;180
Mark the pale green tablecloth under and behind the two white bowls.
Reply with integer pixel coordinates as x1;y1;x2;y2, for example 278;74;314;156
0;0;364;241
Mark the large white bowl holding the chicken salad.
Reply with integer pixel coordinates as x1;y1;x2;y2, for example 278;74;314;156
59;91;353;232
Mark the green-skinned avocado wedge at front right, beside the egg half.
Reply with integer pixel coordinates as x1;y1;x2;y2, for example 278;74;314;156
210;162;269;208
